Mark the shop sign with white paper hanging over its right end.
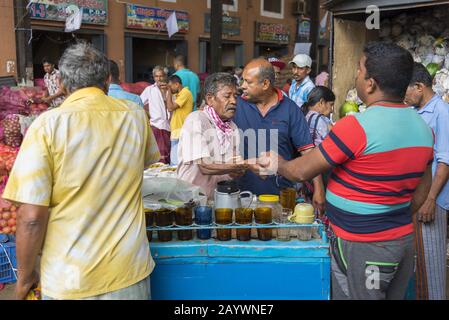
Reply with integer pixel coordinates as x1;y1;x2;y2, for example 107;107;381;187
126;4;190;33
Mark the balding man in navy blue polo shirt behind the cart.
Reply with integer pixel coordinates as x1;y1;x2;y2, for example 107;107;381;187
234;59;325;210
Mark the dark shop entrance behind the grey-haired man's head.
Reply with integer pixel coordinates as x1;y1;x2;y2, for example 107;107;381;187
32;29;106;79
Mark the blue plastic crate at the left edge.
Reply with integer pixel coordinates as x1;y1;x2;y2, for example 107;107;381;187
0;235;17;283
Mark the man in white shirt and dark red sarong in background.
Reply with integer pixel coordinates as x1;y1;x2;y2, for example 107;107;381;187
140;66;171;164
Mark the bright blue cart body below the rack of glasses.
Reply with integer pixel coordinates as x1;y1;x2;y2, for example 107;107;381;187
149;222;330;300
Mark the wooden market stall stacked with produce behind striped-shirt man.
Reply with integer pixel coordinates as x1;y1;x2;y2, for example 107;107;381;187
324;0;449;118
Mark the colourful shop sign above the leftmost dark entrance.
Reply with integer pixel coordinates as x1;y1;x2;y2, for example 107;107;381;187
29;0;108;25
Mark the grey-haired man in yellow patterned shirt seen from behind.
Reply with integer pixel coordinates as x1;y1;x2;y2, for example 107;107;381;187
3;43;160;300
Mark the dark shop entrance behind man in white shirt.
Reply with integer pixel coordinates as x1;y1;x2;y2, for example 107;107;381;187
125;35;187;83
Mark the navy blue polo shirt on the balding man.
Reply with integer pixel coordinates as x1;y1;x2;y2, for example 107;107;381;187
233;90;313;195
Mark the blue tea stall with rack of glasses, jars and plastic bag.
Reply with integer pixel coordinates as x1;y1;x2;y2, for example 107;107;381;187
143;165;330;300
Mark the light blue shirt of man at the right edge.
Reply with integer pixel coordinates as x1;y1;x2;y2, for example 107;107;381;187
418;94;449;210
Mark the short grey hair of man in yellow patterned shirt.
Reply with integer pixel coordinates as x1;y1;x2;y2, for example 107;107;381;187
59;42;109;92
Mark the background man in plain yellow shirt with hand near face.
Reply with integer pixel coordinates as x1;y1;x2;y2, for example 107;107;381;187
166;75;193;166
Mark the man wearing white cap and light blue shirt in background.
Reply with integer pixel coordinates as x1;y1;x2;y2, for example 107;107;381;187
289;54;315;107
